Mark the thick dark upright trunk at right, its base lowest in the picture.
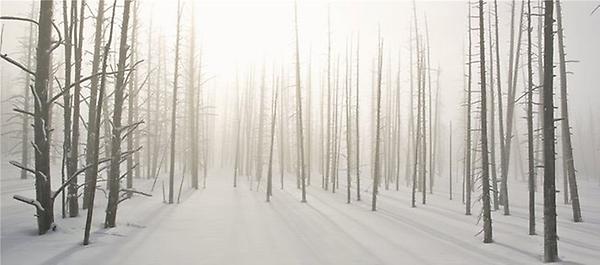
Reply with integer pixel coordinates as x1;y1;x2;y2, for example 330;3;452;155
543;0;558;262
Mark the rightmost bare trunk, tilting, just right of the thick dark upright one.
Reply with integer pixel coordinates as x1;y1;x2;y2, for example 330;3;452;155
556;0;583;223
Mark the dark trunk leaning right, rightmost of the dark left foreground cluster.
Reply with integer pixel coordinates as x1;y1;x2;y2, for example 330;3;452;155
104;0;131;228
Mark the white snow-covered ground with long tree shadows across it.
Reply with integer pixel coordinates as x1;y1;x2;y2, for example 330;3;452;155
1;166;600;265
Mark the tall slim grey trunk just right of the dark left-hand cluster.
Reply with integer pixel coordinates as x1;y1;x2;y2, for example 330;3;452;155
169;0;181;204
